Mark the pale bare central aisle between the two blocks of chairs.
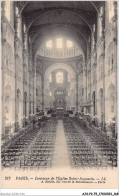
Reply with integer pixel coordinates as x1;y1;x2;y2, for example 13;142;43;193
52;120;70;168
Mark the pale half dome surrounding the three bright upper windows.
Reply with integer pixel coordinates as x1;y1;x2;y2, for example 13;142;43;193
36;35;84;59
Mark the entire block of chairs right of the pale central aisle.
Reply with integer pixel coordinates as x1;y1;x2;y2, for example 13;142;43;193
64;118;117;168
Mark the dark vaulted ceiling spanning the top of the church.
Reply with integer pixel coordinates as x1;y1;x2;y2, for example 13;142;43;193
16;1;103;59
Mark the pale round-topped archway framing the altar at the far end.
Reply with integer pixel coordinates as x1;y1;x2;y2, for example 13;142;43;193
44;63;76;109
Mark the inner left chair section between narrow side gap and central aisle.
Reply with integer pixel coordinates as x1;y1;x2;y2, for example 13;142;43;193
20;119;57;169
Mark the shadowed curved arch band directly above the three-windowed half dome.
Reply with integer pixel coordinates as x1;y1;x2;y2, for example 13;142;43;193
34;24;87;59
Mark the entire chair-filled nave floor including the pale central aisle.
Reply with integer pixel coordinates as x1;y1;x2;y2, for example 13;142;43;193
2;117;117;169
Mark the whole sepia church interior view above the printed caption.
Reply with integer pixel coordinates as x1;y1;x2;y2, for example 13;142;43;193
1;1;118;169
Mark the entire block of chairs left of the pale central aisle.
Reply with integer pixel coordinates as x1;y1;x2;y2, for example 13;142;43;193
2;120;56;168
